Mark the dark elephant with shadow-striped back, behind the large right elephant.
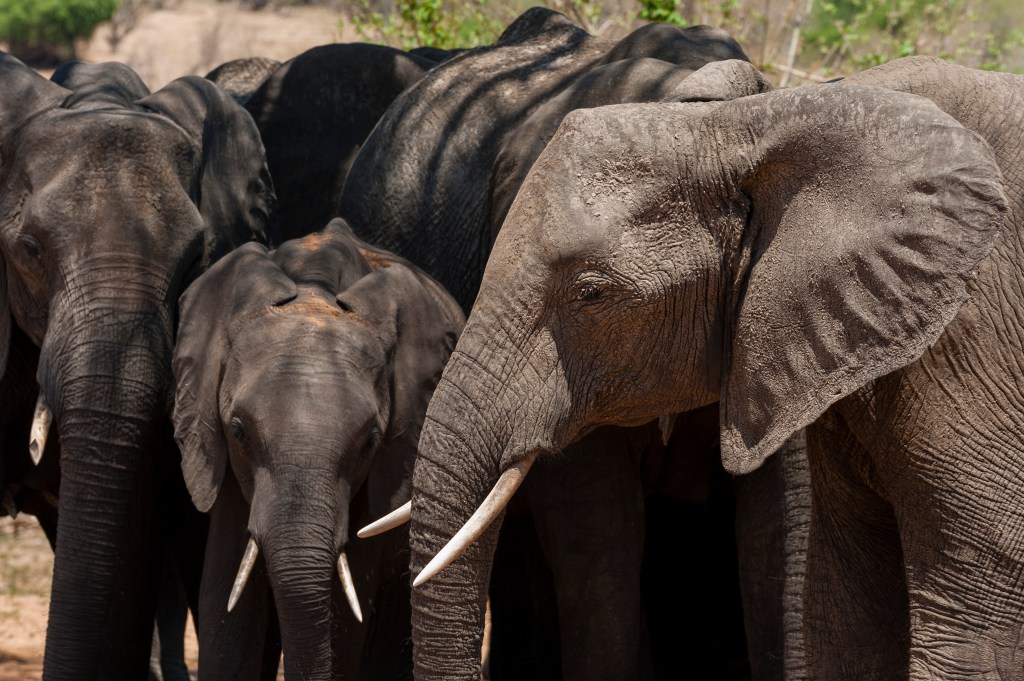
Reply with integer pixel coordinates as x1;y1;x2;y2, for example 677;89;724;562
339;9;802;679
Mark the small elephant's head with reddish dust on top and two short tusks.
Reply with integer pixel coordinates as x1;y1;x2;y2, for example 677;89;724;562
174;220;464;678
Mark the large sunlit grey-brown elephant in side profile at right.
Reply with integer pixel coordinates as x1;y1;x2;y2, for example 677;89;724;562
411;59;1024;680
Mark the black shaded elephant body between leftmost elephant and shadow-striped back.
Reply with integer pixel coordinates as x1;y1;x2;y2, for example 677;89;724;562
246;43;434;239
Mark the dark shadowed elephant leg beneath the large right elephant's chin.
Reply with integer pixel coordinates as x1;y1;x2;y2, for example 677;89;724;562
526;428;644;681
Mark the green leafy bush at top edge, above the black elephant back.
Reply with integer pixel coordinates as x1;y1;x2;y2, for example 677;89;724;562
349;0;510;49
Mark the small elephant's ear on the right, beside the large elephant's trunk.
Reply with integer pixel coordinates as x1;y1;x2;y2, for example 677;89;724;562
338;259;466;517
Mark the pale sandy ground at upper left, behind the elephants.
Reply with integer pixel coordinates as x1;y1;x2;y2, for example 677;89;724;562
79;0;361;90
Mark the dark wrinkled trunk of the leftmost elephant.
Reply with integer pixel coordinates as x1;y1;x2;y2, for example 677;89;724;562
39;287;171;680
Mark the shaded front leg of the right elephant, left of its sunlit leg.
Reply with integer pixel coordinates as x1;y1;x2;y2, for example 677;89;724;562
804;418;909;681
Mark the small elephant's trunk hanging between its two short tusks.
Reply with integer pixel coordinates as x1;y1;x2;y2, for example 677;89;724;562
262;518;338;681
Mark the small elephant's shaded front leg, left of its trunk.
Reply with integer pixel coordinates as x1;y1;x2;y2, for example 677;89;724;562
199;472;272;681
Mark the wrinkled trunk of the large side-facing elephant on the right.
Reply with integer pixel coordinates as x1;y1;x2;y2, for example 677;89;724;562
410;346;520;681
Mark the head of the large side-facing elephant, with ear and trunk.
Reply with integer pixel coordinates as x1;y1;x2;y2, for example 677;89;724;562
411;78;1006;679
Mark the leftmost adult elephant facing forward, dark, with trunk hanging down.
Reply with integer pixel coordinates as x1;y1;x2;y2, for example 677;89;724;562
0;55;275;679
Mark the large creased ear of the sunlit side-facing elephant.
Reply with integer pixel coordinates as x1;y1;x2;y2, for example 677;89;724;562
713;84;1007;473
